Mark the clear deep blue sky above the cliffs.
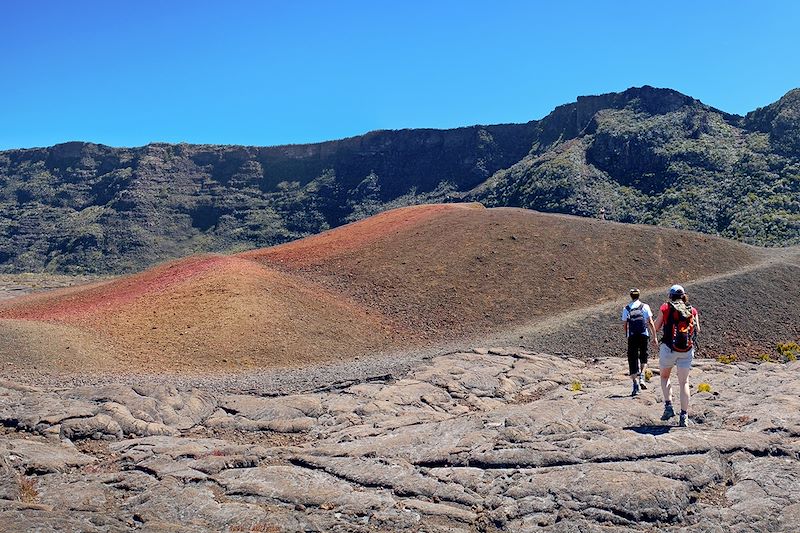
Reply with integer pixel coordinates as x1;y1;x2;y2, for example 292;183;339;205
0;0;800;149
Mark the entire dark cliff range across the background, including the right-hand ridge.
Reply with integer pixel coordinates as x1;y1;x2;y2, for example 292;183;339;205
0;87;800;272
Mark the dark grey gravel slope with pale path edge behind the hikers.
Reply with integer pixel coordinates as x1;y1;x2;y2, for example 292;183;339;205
484;247;800;358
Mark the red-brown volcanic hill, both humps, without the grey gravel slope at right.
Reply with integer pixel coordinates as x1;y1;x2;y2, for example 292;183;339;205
0;204;792;372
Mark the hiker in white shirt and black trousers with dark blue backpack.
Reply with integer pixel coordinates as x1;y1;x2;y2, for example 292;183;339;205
622;289;658;396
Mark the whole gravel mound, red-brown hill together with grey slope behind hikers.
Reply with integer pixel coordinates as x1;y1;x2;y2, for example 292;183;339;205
0;204;800;380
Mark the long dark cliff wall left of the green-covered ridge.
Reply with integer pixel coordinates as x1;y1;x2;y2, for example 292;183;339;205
0;124;533;273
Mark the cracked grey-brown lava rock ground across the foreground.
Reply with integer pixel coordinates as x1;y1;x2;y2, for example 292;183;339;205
0;349;800;533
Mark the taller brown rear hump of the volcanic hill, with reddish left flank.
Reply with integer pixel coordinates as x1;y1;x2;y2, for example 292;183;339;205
240;204;763;336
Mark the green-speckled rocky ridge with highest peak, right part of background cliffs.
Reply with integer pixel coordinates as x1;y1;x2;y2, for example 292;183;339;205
470;87;800;246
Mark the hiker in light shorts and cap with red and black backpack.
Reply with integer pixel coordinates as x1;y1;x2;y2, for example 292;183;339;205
656;285;700;427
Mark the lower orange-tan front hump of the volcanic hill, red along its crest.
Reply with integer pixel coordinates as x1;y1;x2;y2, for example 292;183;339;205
0;256;401;372
